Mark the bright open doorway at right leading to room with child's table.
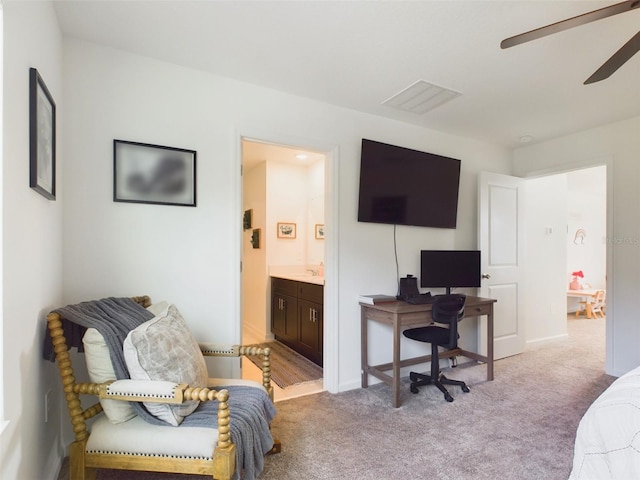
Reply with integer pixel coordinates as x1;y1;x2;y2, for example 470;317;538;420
525;165;607;364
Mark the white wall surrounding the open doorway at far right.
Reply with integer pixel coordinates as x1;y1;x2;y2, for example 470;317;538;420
513;117;640;375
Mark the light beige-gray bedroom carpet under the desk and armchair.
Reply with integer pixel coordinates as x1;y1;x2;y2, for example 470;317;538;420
60;319;614;480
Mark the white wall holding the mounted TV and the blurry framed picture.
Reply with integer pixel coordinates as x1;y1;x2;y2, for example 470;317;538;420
64;40;510;398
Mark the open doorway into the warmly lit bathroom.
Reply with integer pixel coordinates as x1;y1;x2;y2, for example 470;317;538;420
241;138;327;401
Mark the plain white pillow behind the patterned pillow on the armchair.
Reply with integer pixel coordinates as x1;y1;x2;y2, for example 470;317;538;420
82;302;169;423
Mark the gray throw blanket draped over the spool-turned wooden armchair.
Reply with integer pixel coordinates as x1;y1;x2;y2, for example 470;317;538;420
44;297;276;480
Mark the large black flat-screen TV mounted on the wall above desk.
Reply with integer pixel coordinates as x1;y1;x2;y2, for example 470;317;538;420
358;139;460;228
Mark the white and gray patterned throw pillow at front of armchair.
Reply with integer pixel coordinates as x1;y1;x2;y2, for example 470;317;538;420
123;305;208;426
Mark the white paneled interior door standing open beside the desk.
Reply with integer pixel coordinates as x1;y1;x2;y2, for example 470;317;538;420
478;172;526;360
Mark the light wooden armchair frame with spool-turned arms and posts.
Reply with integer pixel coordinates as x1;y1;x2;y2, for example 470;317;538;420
47;295;280;480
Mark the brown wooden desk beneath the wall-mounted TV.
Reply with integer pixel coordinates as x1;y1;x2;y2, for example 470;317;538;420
360;296;496;408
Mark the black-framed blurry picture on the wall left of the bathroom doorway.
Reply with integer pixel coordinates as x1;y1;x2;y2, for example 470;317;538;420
113;140;196;207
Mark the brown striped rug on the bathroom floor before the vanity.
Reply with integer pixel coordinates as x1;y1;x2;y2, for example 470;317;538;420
247;342;322;388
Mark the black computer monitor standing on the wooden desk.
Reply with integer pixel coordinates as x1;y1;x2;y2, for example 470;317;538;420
420;250;480;293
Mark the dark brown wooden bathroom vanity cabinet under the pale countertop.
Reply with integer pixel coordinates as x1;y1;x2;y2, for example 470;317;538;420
271;277;324;366
